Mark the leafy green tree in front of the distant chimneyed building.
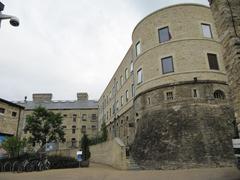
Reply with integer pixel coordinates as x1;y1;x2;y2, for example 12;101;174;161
24;106;65;149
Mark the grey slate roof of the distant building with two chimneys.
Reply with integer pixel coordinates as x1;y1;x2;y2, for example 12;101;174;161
17;100;98;110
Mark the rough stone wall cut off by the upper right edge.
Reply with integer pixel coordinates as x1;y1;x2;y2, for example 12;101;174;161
209;0;240;130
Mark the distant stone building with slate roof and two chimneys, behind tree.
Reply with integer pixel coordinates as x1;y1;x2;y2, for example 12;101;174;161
18;93;98;149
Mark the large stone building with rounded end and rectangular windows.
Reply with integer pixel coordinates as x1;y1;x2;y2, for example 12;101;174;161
99;4;234;168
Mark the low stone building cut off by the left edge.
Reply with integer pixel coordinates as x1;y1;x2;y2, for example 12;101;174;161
0;98;24;157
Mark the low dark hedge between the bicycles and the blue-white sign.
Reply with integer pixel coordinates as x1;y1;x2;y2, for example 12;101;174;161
48;156;79;169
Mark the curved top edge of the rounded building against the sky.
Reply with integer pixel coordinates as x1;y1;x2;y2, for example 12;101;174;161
132;3;210;37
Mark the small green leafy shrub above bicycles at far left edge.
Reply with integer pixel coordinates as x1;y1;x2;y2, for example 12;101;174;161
1;136;26;158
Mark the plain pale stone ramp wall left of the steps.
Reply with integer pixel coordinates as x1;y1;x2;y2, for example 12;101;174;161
90;138;128;169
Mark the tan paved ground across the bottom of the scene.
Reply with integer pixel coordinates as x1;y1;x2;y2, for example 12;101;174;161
0;164;240;180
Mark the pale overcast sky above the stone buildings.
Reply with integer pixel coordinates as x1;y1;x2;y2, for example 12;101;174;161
0;0;208;101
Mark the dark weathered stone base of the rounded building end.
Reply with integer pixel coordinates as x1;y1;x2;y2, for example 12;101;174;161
131;83;234;169
